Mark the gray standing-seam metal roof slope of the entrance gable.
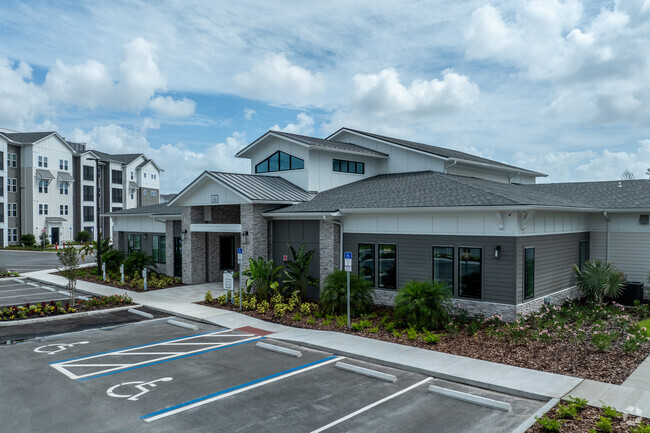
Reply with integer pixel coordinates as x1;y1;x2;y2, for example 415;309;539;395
209;171;314;202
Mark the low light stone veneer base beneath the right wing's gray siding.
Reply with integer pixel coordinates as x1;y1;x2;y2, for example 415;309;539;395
373;286;582;322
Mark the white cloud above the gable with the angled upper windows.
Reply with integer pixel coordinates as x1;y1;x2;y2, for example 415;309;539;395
235;53;325;106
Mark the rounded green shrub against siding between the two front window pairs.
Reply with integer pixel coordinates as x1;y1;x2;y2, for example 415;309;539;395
395;280;450;329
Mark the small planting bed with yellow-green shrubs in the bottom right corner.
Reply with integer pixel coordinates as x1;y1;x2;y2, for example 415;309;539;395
526;398;650;433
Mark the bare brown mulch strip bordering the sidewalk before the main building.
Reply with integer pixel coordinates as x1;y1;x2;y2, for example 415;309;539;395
200;301;650;385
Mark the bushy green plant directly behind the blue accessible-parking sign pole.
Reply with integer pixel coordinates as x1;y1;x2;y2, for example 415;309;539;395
320;270;374;316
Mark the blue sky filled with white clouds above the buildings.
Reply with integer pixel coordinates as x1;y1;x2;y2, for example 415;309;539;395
0;0;650;193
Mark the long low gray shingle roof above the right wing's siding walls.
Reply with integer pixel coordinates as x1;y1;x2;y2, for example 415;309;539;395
269;171;650;213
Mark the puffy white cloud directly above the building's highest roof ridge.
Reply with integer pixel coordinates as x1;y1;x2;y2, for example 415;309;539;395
354;69;479;118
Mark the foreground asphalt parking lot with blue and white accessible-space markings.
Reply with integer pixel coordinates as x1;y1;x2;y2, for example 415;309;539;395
0;318;545;432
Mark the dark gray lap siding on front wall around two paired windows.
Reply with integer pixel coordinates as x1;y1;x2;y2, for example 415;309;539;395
343;233;516;304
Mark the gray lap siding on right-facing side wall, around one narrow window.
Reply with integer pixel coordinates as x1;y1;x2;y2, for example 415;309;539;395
516;232;589;304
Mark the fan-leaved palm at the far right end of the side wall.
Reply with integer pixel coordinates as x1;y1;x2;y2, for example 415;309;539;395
573;260;625;304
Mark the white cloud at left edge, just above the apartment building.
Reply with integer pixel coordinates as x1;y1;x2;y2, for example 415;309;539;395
0;58;50;125
